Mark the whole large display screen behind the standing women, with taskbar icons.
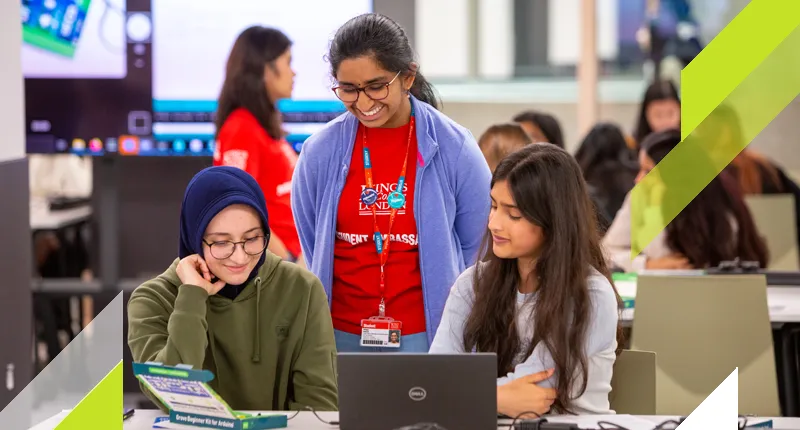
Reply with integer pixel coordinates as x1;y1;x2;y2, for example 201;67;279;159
21;0;372;156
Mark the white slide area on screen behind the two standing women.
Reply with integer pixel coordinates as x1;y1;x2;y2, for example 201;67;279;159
152;0;372;110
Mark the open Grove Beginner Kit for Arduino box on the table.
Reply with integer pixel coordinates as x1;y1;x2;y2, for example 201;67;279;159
133;362;288;430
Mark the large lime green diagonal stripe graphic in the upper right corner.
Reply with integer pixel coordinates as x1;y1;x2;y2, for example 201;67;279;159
631;0;800;258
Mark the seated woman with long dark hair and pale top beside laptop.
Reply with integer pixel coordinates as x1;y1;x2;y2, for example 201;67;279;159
430;145;621;417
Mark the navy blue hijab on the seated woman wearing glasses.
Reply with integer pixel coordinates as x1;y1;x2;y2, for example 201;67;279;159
178;166;270;299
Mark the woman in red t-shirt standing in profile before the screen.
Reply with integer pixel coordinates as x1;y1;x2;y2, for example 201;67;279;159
214;26;305;266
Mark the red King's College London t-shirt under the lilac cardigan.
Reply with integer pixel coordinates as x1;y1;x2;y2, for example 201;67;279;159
331;120;425;335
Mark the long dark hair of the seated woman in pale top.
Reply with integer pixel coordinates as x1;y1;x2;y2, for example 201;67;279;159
464;145;622;412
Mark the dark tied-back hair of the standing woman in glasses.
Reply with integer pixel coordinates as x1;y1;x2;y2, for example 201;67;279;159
328;13;440;109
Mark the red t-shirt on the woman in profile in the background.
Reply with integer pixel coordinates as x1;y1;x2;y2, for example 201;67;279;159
214;108;301;257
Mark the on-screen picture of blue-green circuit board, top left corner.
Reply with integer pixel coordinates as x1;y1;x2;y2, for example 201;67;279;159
20;0;127;79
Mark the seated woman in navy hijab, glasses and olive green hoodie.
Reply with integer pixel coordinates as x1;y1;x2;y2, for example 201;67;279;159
128;166;338;410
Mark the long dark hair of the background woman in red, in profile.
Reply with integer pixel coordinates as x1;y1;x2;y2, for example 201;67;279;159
214;26;292;139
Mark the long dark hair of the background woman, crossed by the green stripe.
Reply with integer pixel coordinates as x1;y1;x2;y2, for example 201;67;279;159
642;130;769;268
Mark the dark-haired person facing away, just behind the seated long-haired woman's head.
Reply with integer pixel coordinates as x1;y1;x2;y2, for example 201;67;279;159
575;123;639;230
